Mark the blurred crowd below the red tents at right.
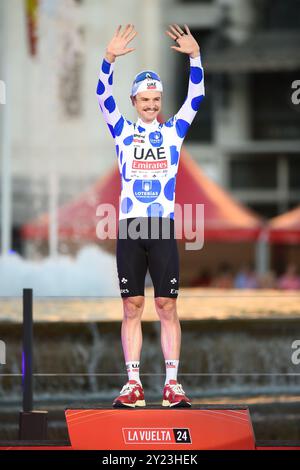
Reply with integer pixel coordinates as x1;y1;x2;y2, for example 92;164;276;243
191;263;300;290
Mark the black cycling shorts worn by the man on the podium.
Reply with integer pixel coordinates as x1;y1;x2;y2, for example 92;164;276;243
117;217;179;298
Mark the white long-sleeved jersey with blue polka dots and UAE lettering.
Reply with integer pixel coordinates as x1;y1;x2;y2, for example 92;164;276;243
97;56;204;220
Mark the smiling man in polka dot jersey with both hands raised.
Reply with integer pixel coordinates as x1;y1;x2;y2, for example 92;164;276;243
97;24;204;408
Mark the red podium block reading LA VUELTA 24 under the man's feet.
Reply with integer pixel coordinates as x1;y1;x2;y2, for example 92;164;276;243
65;406;255;450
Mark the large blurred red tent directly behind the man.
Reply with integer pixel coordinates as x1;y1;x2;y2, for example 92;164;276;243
22;149;262;242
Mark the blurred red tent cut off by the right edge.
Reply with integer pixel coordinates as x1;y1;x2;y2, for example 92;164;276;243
268;206;300;245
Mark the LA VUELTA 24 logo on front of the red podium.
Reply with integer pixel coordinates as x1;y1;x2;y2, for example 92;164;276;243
122;428;192;444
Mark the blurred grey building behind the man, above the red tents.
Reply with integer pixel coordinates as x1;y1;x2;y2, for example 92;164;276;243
0;0;300;254
